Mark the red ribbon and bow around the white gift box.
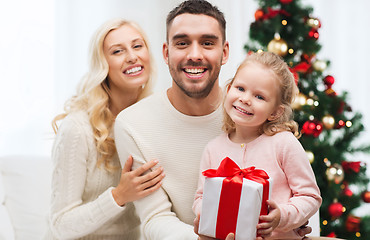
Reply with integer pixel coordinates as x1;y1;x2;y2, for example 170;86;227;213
203;157;269;239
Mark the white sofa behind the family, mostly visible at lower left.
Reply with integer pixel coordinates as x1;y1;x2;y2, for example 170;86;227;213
0;155;320;240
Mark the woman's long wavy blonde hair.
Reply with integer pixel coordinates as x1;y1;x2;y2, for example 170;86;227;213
52;18;154;170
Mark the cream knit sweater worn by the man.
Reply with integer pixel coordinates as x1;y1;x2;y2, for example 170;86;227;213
114;92;222;240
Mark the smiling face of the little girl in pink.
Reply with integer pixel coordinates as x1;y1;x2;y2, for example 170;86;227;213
224;63;284;130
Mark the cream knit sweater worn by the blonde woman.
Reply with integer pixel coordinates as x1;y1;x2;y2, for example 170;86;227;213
48;111;140;240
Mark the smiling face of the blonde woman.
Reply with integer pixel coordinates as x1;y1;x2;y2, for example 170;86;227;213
103;25;150;92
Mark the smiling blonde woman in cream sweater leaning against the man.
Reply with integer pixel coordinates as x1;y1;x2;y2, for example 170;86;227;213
48;19;164;239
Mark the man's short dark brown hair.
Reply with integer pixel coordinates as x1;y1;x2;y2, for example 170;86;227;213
166;0;226;42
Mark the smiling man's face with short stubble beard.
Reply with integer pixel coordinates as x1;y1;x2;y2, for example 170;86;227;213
163;13;229;98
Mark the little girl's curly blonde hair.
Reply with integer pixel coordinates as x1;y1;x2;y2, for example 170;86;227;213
222;52;300;138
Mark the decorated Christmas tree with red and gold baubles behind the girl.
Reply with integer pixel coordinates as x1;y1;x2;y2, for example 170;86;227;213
245;0;370;239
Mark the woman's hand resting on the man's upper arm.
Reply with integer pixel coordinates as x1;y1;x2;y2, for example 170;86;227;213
112;156;165;206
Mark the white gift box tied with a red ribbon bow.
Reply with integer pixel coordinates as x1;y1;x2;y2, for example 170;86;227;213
198;157;271;240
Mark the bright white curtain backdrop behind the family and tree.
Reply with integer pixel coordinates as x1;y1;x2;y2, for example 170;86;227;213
0;0;370;168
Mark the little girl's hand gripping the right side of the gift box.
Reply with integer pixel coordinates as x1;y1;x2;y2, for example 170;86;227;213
257;200;281;240
